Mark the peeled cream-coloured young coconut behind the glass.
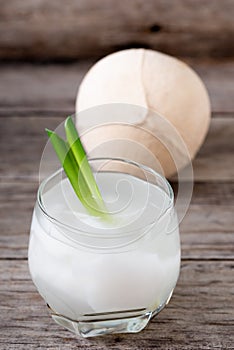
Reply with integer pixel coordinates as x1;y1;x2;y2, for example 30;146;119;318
76;49;210;177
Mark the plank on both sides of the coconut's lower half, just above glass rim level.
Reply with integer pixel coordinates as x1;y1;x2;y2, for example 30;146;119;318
0;115;234;182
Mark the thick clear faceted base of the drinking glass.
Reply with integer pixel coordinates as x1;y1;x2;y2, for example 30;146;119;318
48;293;172;338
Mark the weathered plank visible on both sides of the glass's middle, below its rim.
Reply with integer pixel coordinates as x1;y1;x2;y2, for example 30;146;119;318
0;182;234;260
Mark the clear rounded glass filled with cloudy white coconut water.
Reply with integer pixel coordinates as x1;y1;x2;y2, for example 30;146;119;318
28;158;180;337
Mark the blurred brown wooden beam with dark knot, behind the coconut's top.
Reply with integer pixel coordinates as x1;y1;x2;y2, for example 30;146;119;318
0;0;234;60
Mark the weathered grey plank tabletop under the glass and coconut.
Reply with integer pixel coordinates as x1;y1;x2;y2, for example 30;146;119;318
0;60;234;350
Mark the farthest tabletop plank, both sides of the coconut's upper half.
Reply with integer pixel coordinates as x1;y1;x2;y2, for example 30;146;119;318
0;60;234;117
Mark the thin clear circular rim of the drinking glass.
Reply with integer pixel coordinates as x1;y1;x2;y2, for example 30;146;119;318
36;157;174;238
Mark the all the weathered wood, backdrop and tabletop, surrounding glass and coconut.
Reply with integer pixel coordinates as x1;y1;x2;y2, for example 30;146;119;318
0;0;234;350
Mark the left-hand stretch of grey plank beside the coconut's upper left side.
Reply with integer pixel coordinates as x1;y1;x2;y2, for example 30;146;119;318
0;61;91;116
